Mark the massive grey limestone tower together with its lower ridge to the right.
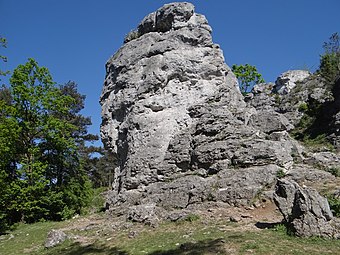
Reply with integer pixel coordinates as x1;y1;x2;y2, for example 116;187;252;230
100;3;340;237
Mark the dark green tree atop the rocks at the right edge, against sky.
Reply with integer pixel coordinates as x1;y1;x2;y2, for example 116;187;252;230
317;33;340;83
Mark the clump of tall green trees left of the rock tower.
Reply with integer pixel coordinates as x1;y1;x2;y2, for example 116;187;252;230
0;59;91;230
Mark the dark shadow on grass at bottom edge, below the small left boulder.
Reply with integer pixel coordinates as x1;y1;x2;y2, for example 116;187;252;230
47;243;129;255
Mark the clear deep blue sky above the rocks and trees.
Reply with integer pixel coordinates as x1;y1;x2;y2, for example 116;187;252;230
0;0;340;144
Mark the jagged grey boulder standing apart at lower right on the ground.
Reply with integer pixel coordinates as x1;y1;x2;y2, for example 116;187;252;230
274;180;339;238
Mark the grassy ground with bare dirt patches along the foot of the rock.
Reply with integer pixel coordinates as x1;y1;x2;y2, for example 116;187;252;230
0;215;340;255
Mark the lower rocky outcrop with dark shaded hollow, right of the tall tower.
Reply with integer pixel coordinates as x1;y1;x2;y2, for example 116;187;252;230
245;70;340;148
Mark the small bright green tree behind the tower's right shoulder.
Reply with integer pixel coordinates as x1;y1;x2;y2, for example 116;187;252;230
231;64;265;94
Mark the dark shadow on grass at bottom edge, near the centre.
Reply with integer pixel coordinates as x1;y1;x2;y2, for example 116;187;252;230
149;239;225;255
